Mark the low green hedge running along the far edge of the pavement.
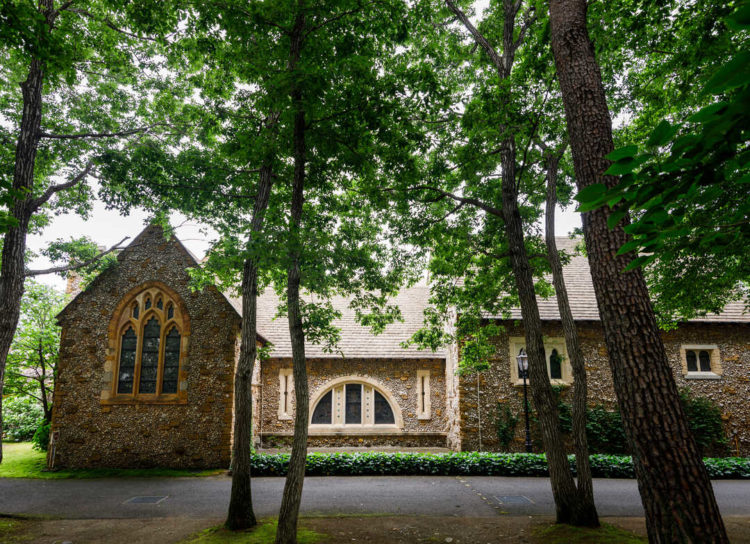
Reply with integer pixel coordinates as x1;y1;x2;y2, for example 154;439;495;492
252;452;750;479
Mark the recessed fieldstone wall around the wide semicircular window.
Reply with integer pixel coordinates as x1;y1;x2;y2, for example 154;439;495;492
256;358;447;447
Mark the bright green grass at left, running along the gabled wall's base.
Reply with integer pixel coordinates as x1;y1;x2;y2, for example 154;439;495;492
0;442;225;480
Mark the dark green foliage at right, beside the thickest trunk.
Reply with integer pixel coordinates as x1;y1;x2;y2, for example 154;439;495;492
576;1;750;322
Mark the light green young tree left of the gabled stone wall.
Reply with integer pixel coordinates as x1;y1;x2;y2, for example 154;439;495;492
5;281;66;419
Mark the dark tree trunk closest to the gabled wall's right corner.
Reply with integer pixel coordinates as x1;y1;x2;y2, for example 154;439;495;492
226;165;280;531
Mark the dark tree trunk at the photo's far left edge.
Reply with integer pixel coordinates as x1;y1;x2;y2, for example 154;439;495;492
0;50;45;463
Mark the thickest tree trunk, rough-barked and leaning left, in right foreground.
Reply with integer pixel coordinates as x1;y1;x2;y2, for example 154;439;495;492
550;0;728;543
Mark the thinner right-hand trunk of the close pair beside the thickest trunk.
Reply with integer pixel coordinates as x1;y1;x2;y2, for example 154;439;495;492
545;154;599;527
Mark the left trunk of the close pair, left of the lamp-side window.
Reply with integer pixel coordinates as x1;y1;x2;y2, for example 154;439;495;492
502;139;579;524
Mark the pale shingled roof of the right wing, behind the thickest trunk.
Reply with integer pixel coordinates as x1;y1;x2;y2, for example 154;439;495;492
485;236;750;323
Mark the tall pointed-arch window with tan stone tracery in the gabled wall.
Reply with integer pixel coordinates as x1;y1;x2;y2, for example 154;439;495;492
108;282;190;403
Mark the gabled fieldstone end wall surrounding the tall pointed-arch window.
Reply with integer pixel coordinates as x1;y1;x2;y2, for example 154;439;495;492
50;225;240;468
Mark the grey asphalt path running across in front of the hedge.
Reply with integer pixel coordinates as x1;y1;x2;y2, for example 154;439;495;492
0;476;750;518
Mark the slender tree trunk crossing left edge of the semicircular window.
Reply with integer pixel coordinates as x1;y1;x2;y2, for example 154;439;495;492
276;14;310;544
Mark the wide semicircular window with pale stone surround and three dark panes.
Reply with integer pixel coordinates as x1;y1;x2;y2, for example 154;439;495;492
310;376;403;432
